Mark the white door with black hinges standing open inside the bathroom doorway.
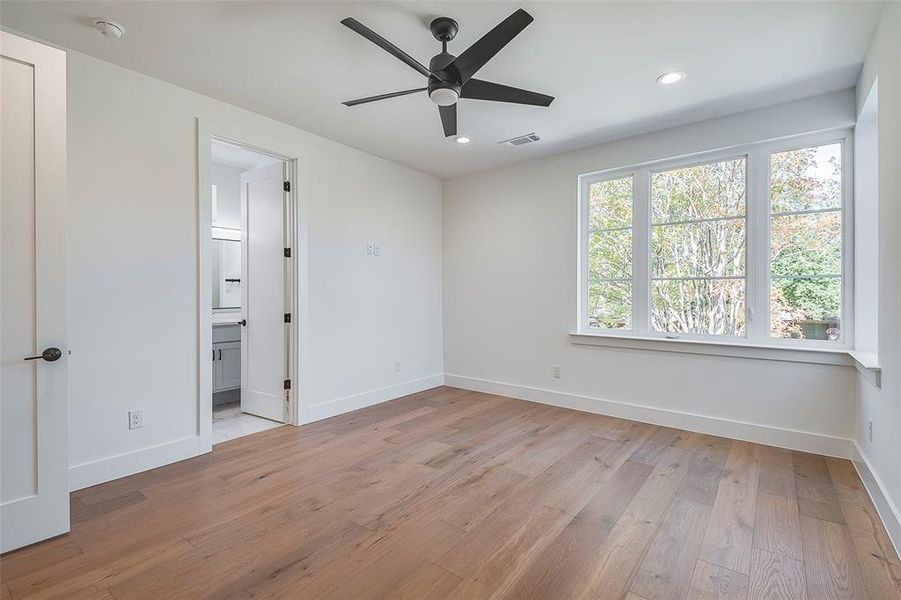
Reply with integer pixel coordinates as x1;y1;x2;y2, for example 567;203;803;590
241;163;287;422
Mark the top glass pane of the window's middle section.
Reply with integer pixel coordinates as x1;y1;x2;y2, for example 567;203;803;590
651;158;745;223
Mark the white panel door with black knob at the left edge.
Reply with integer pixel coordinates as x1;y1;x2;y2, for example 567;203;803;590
0;32;69;552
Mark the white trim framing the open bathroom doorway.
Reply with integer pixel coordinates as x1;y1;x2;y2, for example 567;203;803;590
196;118;300;452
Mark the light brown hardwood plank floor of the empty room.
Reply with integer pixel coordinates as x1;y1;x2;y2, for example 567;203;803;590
0;387;901;600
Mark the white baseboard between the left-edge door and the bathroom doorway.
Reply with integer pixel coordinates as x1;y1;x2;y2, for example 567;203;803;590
69;435;203;492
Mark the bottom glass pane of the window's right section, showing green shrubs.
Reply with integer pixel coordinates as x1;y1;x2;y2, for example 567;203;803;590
770;277;842;341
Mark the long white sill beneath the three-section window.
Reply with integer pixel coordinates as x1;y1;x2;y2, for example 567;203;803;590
569;332;856;370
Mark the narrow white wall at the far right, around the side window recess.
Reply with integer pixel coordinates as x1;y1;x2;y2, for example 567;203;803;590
854;3;901;551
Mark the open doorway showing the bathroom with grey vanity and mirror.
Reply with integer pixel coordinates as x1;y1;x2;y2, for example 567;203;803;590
210;139;292;445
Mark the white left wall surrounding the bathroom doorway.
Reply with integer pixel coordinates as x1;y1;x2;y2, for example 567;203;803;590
68;52;442;488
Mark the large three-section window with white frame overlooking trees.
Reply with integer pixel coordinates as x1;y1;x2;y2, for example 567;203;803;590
580;133;850;348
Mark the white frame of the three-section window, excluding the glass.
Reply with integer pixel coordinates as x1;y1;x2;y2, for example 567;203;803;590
576;128;854;352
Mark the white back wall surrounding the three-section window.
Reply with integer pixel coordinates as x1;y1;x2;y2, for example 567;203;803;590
444;90;855;456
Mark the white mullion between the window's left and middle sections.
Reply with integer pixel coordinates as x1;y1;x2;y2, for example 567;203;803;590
632;168;651;335
